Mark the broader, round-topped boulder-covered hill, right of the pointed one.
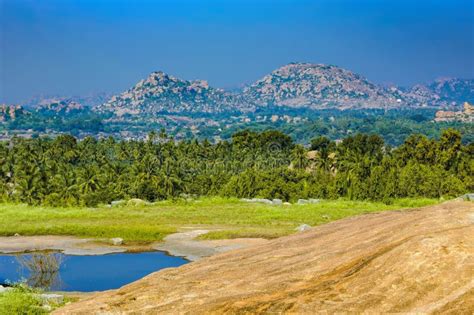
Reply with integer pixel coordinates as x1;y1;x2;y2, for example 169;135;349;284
243;63;407;109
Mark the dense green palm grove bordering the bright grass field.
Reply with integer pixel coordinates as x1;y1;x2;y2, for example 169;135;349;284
0;129;474;206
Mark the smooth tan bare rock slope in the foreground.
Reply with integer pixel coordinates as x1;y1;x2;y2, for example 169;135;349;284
56;201;474;314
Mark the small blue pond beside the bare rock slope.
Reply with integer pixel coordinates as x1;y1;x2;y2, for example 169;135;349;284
0;252;188;292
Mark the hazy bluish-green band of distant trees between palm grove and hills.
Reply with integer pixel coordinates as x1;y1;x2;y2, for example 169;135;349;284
0;106;474;146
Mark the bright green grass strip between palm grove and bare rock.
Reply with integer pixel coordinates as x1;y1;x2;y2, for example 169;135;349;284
0;198;439;243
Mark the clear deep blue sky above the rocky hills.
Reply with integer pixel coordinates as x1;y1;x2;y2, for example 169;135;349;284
0;0;474;103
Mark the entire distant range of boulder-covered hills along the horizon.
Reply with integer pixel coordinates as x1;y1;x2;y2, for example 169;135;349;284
20;63;474;118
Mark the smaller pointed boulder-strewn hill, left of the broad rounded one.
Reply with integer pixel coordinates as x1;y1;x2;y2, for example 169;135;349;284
97;71;252;116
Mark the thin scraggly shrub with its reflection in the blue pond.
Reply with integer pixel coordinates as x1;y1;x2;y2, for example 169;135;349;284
16;253;64;290
